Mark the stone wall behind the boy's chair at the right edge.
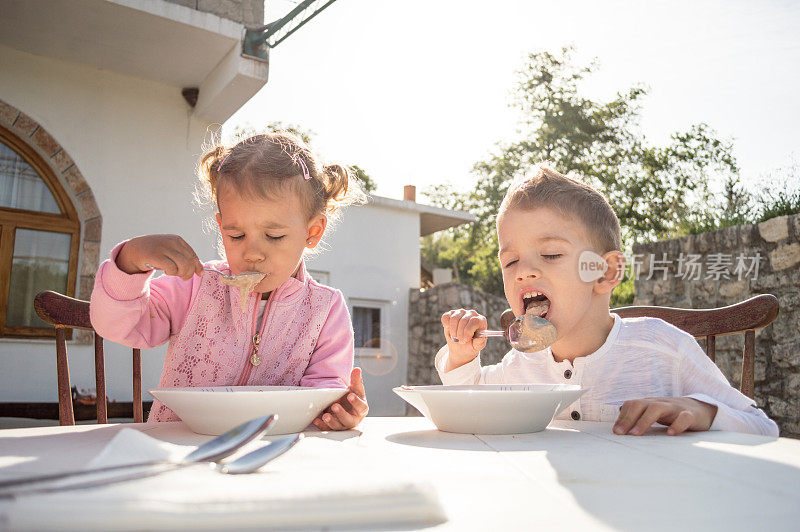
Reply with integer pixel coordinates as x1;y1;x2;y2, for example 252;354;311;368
629;215;800;436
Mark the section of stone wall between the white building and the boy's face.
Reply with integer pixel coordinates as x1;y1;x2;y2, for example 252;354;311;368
407;283;509;385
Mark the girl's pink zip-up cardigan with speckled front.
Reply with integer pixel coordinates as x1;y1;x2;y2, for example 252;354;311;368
90;242;353;421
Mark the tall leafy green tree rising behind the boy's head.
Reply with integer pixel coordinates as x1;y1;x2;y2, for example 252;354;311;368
423;48;738;303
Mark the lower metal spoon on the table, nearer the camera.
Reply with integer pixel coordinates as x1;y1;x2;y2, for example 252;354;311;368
0;434;303;499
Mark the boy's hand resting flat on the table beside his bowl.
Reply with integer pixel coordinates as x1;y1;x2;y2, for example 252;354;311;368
613;397;717;436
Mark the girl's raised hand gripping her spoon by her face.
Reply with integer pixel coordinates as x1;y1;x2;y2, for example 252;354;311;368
116;235;203;280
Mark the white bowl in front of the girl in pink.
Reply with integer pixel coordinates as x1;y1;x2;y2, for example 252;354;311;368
148;386;347;435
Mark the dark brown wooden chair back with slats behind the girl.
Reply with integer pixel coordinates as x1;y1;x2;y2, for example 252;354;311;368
33;290;144;425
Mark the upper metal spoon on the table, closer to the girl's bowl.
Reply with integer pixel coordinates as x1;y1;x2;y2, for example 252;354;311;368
0;414;278;495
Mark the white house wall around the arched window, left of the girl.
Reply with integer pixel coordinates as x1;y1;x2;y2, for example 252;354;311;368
0;47;216;402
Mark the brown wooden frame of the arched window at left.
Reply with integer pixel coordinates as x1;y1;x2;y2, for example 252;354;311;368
0;126;81;339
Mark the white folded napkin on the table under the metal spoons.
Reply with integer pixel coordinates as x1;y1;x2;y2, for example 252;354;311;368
0;429;446;530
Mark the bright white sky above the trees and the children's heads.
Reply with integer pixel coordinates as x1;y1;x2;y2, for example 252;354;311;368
225;0;800;201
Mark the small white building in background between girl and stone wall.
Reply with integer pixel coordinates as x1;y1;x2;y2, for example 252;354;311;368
307;196;475;415
